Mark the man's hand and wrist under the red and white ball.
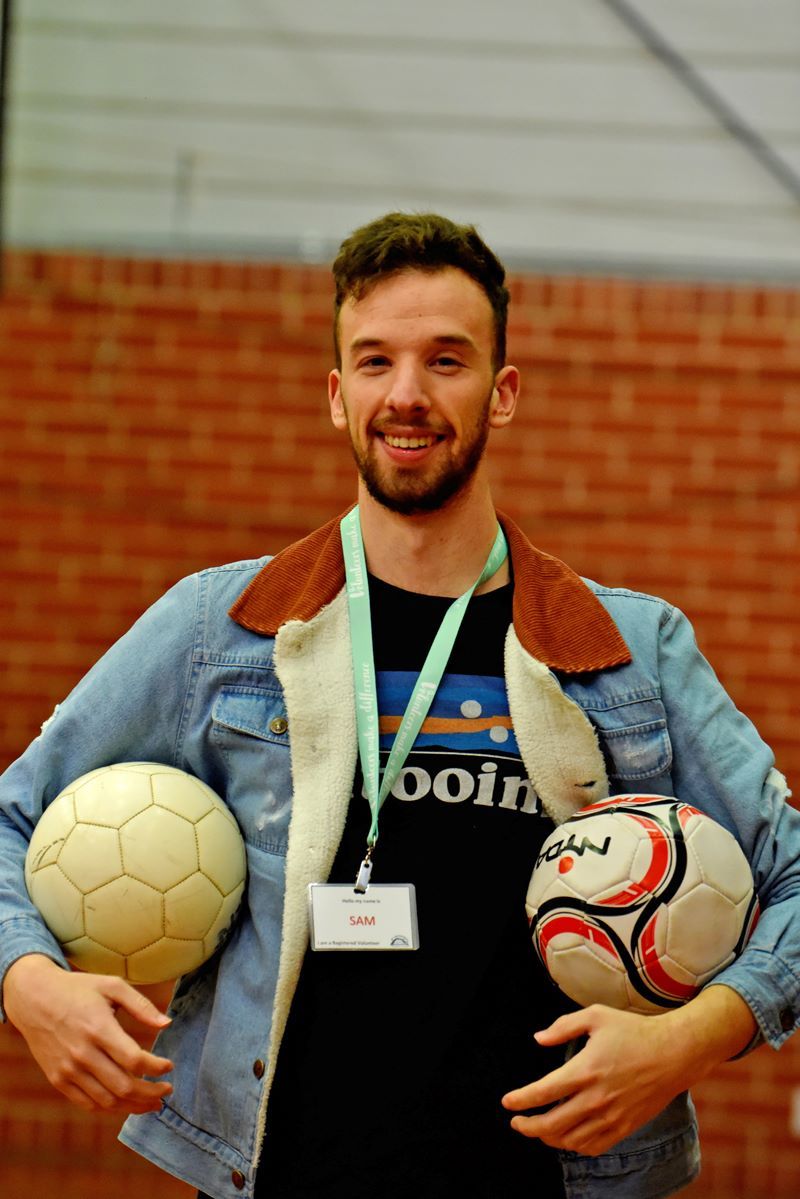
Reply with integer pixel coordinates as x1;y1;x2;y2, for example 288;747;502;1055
503;986;756;1155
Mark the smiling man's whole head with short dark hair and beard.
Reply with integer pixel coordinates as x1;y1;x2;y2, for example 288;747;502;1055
329;215;519;516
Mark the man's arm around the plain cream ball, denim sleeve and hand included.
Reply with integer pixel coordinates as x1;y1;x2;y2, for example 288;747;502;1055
0;570;198;1111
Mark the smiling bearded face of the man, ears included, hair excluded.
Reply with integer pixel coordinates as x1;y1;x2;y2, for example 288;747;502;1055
329;267;517;514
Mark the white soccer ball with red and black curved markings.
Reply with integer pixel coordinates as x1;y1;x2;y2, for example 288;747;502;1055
525;795;759;1014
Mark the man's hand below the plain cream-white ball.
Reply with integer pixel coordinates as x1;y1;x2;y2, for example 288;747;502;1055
2;953;173;1113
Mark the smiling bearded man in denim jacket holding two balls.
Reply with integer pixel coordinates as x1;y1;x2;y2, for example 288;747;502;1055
0;213;800;1199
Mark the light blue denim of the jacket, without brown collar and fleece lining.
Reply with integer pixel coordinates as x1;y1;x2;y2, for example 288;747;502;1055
0;560;800;1199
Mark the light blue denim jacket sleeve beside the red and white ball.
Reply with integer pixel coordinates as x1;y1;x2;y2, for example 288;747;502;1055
658;608;800;1048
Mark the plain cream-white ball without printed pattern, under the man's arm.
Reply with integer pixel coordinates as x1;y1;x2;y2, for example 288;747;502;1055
25;761;246;983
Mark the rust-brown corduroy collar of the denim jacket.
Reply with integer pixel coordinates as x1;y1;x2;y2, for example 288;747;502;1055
230;513;631;674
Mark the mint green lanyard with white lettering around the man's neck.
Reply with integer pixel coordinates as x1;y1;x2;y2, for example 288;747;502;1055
341;507;509;890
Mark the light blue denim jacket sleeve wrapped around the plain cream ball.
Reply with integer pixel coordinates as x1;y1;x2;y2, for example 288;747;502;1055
0;577;198;1018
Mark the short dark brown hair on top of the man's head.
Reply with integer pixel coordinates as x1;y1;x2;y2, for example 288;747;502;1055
332;212;509;370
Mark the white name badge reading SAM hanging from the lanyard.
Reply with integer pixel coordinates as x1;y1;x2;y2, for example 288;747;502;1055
308;882;420;950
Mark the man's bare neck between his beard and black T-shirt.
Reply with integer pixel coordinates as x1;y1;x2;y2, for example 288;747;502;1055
359;472;510;596
